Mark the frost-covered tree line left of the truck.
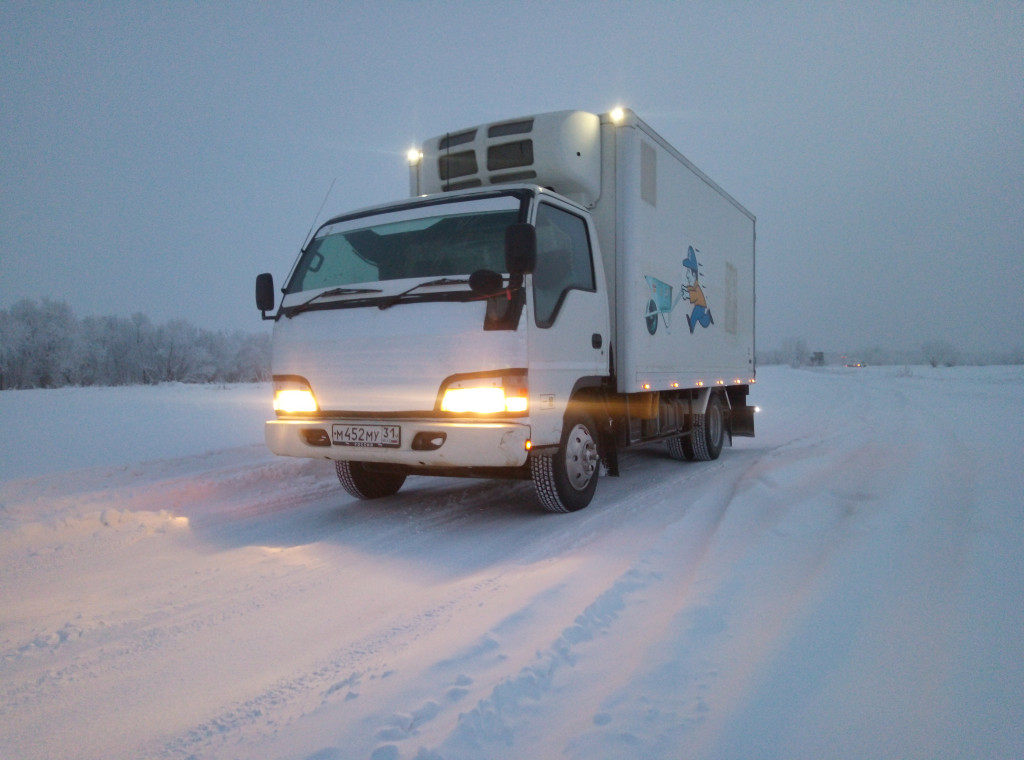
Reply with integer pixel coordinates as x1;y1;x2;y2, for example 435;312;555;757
0;298;270;390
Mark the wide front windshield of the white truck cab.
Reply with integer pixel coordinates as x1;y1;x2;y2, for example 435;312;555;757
285;195;520;294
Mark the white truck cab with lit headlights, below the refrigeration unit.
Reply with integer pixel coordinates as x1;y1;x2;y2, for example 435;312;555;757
263;185;610;508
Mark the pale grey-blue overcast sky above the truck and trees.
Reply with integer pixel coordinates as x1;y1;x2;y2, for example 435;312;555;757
0;0;1024;351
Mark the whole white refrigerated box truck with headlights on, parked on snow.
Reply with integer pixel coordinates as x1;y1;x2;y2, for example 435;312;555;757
256;110;755;512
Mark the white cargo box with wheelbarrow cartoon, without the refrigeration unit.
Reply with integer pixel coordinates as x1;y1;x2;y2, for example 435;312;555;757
592;112;756;392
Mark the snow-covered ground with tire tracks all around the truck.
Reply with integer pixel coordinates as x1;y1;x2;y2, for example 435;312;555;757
0;367;1024;760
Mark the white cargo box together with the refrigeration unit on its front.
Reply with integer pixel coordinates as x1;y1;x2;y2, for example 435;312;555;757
411;111;756;393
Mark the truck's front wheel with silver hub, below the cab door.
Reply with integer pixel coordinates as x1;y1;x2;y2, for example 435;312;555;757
529;411;601;512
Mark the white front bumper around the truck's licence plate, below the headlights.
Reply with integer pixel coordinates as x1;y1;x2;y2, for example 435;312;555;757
263;419;530;469
